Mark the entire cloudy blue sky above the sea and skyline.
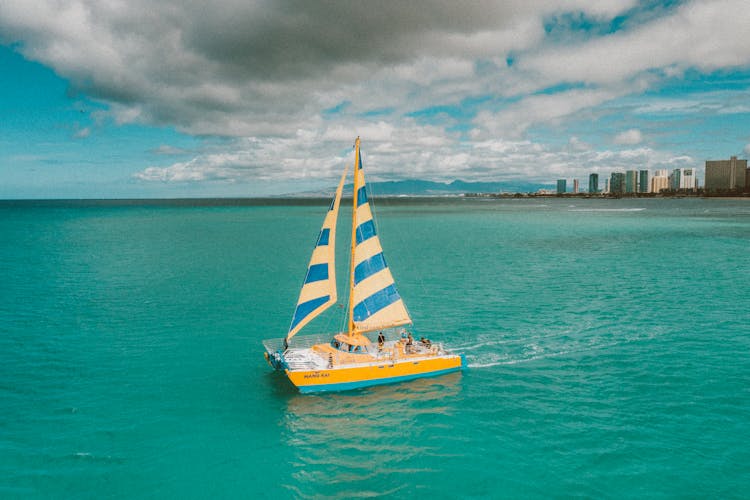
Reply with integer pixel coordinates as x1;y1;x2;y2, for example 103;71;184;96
0;0;750;199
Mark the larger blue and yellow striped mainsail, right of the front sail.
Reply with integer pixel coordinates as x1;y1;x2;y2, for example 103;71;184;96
349;138;411;333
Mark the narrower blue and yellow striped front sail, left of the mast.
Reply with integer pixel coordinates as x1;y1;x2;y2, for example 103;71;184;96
286;169;348;344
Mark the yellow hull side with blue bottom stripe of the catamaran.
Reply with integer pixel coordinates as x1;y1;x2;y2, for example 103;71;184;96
285;354;463;392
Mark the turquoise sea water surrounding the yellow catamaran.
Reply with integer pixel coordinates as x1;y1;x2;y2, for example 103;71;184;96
0;199;750;498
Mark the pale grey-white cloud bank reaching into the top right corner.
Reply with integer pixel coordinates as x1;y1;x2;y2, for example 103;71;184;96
519;0;750;85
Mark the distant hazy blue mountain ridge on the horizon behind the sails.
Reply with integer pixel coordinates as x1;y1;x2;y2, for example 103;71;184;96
296;179;554;196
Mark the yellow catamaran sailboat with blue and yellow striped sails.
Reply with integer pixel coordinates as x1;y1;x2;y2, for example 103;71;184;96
263;137;465;393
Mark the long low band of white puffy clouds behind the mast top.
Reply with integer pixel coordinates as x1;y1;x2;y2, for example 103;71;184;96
135;123;696;190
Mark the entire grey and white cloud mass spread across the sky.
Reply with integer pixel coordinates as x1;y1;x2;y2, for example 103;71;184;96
0;0;750;189
